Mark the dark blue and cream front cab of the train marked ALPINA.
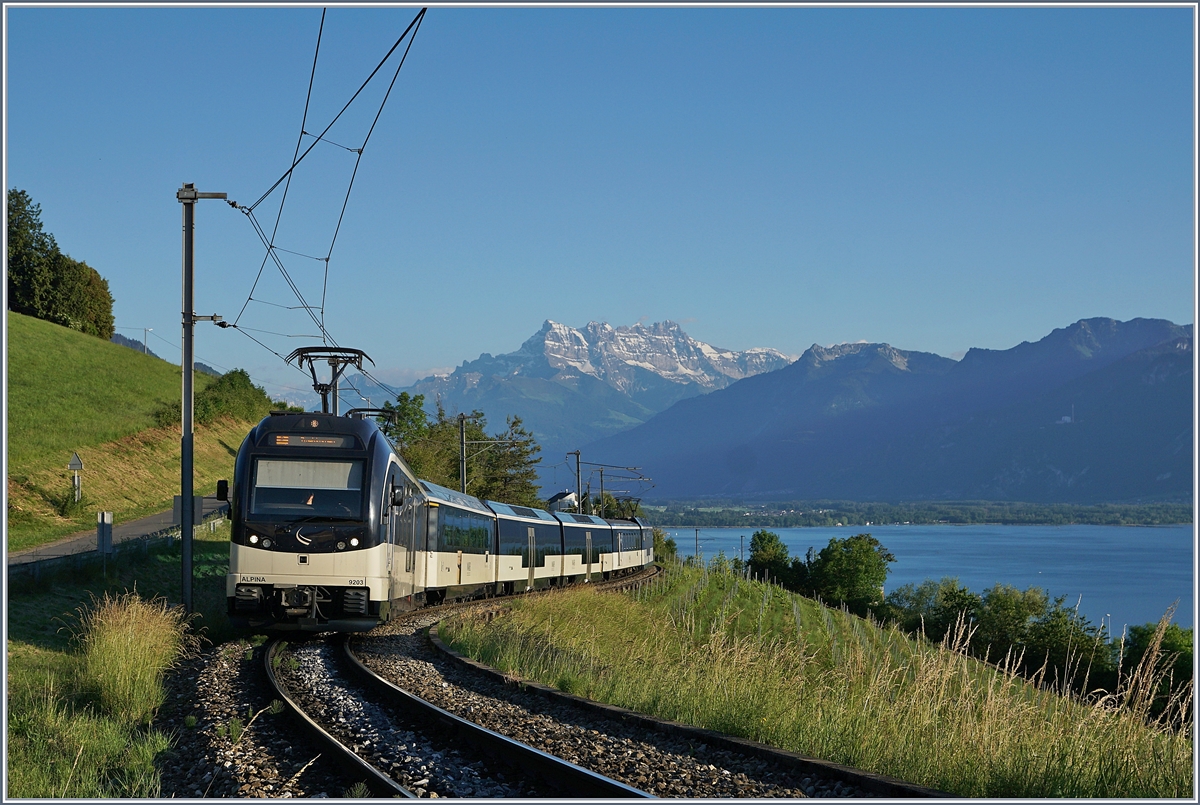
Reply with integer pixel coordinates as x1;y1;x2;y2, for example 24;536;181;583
226;414;405;631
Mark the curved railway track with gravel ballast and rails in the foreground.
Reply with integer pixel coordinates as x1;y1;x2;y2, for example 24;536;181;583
163;575;937;798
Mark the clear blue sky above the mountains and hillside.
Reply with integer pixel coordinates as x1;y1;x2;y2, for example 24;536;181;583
5;6;1195;402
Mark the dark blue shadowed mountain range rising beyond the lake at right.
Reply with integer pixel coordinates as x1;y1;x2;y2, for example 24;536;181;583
586;319;1193;501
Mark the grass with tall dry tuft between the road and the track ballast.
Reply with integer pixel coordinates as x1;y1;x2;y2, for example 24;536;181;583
7;524;233;798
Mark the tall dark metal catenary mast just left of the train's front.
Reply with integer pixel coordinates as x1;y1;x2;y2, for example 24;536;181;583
175;182;227;613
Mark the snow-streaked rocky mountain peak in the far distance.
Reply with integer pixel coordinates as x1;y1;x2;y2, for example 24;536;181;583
407;322;791;462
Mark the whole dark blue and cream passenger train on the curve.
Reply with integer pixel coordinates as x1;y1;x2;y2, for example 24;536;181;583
225;410;654;632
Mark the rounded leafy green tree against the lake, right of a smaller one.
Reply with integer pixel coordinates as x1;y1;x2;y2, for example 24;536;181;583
805;534;896;615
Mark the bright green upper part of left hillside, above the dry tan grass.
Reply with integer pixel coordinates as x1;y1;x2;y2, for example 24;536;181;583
7;311;212;474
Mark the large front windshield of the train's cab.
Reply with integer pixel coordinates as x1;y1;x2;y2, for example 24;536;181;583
250;458;362;519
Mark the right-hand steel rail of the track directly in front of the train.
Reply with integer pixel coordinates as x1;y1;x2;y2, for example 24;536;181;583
343;635;654;799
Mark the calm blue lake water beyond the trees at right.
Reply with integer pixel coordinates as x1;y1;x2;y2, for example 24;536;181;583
665;525;1195;635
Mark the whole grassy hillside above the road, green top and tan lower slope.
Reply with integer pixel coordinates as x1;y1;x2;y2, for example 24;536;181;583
7;312;251;551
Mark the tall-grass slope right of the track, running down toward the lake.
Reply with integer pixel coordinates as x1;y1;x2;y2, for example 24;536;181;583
445;566;1193;798
